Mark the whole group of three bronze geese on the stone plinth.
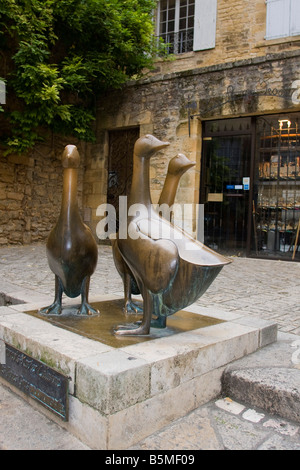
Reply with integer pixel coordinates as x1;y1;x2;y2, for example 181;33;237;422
40;135;231;336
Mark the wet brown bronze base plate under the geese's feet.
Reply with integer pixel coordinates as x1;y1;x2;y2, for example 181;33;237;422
25;299;222;348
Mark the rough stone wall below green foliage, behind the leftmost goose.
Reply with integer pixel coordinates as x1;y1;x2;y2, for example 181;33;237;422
0;140;85;246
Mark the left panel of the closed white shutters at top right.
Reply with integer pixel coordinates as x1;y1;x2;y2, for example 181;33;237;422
266;0;290;39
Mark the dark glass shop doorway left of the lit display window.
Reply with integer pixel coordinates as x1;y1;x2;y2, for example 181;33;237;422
200;118;252;255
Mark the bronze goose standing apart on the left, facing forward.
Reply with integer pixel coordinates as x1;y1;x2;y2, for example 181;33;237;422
40;145;99;315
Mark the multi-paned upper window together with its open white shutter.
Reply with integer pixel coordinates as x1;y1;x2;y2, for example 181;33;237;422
157;0;217;54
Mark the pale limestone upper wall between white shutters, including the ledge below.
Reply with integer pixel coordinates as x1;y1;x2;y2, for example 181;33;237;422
154;0;300;75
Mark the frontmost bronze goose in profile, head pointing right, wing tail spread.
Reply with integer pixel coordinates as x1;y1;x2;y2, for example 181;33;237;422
115;135;230;335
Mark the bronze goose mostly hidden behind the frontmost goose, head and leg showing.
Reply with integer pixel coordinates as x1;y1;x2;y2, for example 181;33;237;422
111;153;196;314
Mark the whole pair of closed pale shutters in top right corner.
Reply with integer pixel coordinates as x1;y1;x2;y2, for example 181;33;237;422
266;0;300;39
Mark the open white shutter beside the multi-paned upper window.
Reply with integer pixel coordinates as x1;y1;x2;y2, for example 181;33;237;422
193;0;217;51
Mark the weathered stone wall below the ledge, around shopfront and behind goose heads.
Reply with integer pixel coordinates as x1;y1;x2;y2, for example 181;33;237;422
92;50;300;239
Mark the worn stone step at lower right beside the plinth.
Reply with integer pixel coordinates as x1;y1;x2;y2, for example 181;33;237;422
222;335;300;423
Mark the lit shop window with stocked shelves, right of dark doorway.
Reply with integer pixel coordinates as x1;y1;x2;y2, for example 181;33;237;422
253;114;300;259
